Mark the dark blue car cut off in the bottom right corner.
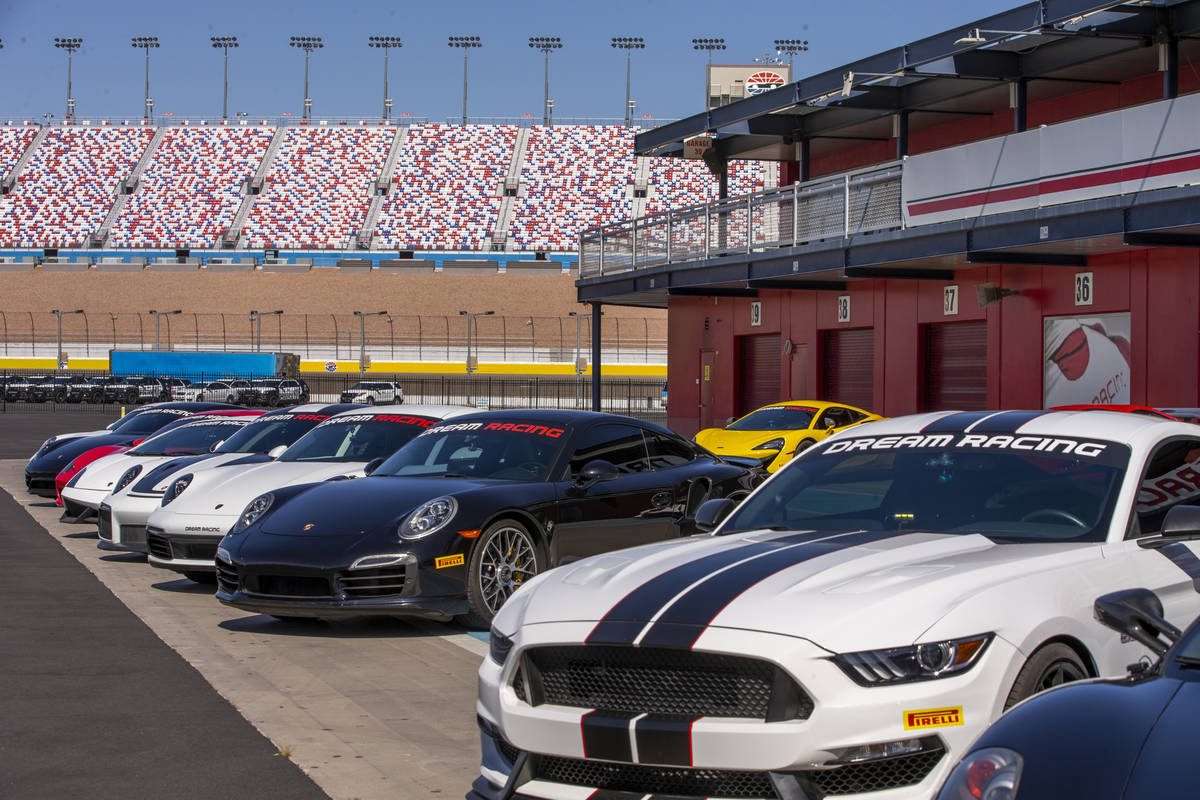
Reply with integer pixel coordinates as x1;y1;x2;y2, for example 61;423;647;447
937;582;1200;800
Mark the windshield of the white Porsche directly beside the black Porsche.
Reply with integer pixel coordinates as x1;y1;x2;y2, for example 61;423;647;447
280;414;437;462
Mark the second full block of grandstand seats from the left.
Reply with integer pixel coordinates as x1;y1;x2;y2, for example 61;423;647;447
109;126;272;247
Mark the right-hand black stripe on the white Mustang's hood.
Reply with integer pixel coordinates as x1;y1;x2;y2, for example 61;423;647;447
640;530;908;648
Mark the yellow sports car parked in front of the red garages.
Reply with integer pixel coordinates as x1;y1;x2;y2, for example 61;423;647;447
696;401;883;473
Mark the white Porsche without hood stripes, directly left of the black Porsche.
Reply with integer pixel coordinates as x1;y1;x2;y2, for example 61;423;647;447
146;405;474;575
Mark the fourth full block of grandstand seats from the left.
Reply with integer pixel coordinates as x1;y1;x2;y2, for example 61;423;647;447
374;125;517;249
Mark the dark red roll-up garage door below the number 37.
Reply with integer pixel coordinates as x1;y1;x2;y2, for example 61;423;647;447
924;319;988;411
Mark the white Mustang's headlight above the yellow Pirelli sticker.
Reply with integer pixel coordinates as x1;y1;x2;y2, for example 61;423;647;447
833;633;992;686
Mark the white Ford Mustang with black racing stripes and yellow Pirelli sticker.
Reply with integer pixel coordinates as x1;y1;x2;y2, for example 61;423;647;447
468;411;1200;800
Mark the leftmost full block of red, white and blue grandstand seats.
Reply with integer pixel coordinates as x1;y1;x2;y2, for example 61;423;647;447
0;126;154;247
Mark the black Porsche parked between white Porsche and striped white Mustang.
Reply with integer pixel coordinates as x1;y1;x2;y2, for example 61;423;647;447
216;410;761;627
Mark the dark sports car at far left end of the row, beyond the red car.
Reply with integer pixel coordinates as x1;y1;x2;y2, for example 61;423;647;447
25;403;238;498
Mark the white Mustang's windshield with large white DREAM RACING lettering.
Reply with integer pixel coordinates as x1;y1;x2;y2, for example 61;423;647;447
721;434;1129;542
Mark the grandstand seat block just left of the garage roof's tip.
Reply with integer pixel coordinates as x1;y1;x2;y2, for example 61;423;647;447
509;125;636;249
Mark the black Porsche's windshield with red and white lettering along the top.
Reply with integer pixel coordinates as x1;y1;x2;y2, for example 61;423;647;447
373;421;568;481
